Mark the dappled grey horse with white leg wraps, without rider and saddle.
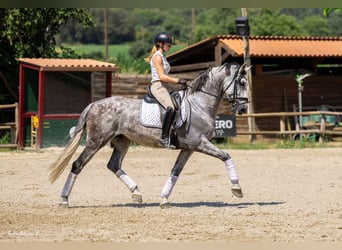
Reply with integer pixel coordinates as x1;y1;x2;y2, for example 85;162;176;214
49;63;250;208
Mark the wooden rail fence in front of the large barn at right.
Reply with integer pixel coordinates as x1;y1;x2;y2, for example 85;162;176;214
237;111;342;143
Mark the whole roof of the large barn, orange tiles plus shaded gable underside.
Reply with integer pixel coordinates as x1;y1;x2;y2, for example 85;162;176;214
167;35;342;71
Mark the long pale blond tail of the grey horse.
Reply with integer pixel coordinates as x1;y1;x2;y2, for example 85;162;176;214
49;104;92;183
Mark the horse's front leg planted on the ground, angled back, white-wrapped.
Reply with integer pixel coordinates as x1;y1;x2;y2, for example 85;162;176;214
160;150;193;208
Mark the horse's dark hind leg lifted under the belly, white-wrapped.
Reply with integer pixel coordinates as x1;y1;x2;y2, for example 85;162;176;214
107;135;142;203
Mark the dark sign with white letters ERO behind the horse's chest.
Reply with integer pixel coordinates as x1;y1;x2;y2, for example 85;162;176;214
214;115;236;138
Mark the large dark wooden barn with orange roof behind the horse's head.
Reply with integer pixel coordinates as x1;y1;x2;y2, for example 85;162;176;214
167;35;342;140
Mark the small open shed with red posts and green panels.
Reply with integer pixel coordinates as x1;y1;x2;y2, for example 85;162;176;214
18;58;117;148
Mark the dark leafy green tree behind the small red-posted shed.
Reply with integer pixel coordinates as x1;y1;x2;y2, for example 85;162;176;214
0;8;93;103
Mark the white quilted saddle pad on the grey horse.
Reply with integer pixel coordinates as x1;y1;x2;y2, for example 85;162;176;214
140;91;188;128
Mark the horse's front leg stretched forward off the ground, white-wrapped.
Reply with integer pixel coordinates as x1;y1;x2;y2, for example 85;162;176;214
196;139;243;198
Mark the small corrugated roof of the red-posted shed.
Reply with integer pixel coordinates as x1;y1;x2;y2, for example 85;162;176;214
18;58;118;72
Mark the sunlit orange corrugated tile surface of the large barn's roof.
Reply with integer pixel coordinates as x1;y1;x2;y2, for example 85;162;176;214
218;36;342;57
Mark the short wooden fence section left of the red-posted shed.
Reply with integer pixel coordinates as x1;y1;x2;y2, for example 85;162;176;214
0;103;19;148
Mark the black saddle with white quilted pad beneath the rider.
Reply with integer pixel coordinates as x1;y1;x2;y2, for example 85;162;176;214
140;86;187;130
